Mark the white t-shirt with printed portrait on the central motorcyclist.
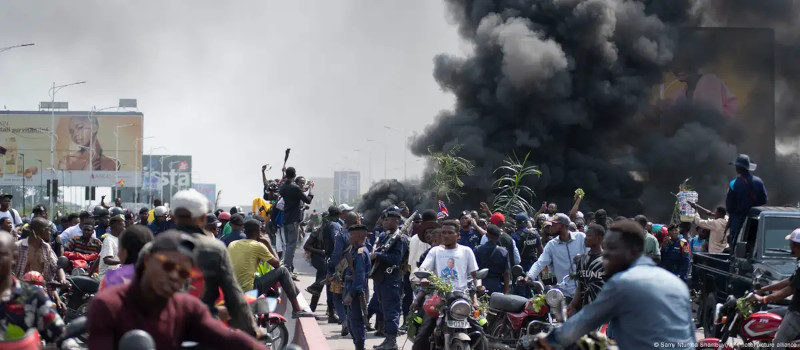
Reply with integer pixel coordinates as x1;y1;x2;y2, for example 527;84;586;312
419;244;478;290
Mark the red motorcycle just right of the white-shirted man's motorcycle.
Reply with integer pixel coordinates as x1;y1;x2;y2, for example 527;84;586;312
486;265;567;350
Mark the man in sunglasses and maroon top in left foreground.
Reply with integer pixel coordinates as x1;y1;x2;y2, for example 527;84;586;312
88;230;266;350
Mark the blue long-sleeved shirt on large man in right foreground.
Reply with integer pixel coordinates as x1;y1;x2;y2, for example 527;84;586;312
547;257;695;349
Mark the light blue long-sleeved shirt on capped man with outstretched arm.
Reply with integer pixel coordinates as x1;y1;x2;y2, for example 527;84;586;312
528;232;587;297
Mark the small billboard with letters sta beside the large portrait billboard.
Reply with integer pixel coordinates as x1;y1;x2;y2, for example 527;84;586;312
141;154;192;201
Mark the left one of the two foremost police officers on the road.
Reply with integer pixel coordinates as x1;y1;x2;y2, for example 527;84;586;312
344;225;370;350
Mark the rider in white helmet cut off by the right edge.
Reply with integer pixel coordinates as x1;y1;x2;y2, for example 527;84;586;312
752;228;800;349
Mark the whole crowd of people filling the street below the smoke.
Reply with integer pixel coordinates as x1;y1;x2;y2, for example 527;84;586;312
0;156;784;350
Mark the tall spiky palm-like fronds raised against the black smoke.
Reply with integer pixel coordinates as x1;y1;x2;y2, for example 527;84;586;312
492;152;542;215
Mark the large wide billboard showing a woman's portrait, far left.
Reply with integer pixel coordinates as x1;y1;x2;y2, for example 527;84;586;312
0;111;143;186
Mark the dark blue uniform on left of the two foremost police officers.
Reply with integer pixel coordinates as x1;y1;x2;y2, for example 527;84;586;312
344;246;370;349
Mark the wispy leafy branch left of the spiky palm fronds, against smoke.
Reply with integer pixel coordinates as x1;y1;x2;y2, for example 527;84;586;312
428;144;475;201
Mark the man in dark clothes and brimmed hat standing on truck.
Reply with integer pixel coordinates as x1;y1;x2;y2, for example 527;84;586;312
725;154;768;246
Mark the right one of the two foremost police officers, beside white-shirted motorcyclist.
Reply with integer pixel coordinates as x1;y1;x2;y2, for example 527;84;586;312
370;211;408;350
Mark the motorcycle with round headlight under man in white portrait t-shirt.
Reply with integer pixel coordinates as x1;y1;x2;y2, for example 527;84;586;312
414;269;489;350
